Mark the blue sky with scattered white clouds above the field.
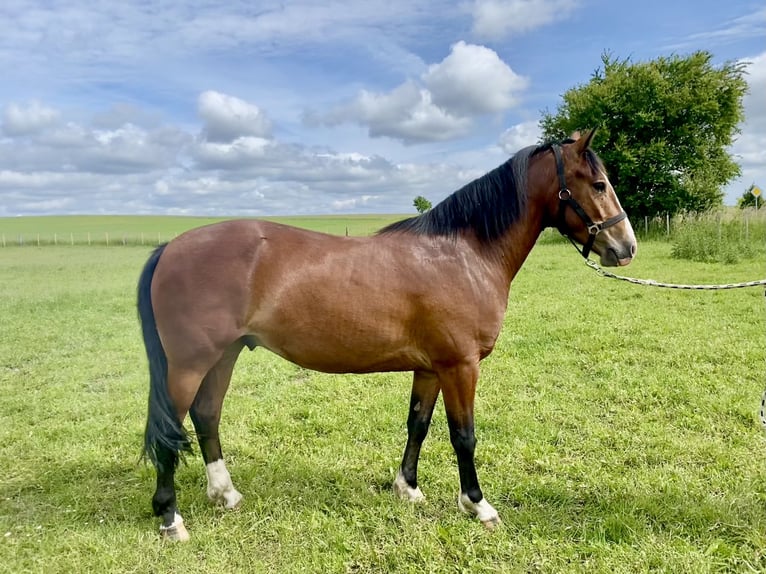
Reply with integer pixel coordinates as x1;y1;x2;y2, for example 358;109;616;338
0;0;766;217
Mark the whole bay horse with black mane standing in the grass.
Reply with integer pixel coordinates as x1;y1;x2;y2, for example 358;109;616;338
138;131;636;540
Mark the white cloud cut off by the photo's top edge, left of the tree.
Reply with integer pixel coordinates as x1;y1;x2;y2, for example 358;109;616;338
471;0;577;40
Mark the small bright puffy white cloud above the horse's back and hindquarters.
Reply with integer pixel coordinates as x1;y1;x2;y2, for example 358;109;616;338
198;91;271;142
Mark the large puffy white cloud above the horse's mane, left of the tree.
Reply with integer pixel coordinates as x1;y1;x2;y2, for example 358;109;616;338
318;41;527;144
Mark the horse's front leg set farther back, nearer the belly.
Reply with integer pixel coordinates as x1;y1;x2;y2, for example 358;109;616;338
394;371;439;502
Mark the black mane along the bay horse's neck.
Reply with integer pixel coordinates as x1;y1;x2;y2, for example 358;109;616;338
378;140;603;243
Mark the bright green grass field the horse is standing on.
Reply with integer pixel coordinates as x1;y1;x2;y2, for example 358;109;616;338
0;218;766;573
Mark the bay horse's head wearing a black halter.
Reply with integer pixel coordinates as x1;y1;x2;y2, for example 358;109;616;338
551;130;636;267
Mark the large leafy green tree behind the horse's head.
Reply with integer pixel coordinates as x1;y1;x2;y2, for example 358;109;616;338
540;52;747;216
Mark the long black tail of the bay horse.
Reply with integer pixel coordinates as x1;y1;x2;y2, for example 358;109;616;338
138;244;191;469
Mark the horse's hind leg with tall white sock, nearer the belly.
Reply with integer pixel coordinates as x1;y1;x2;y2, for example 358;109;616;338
189;341;244;508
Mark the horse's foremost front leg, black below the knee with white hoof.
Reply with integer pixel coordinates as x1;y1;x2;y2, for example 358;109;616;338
438;362;500;528
